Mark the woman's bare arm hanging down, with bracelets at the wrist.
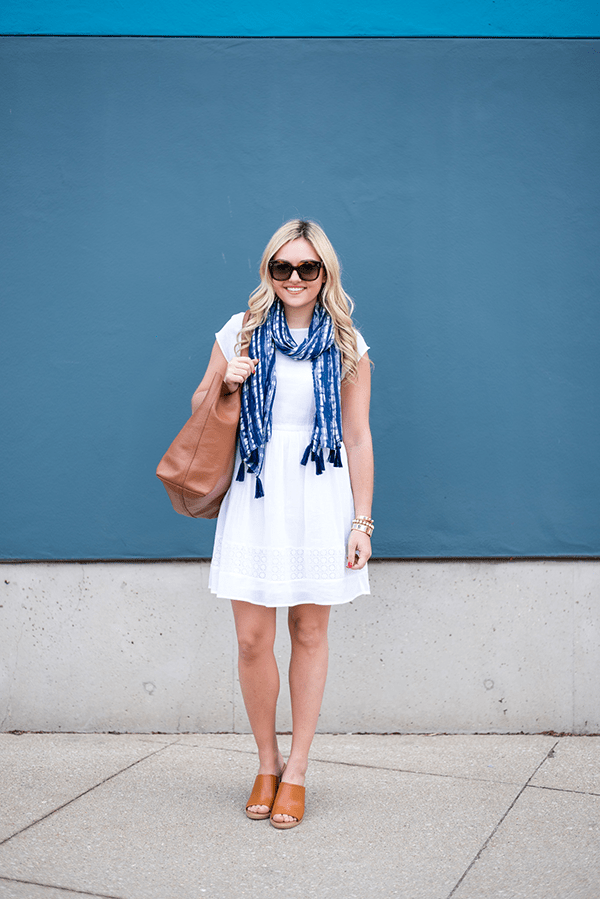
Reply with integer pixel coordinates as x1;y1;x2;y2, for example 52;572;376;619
342;353;374;570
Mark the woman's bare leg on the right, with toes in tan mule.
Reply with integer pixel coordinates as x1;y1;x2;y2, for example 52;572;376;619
273;603;331;822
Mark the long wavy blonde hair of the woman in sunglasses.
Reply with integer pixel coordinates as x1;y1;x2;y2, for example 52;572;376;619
236;219;359;380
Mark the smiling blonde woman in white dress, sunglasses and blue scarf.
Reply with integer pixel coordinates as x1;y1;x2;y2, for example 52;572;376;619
192;220;373;829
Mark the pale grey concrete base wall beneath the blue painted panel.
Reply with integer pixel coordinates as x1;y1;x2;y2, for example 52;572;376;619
0;561;600;734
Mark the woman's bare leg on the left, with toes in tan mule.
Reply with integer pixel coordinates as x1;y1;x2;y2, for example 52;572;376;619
231;600;284;814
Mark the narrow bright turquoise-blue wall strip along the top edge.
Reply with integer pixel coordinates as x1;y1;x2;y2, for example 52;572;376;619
0;0;600;37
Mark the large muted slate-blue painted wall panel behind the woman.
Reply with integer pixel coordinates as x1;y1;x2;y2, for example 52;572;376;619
0;37;600;558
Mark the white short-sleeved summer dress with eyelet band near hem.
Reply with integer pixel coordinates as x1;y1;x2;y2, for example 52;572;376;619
209;312;371;607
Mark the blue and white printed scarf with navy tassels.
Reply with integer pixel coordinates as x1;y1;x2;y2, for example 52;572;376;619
236;299;342;499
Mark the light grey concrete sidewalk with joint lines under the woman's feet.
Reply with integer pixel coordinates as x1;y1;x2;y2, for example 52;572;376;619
0;734;600;899
